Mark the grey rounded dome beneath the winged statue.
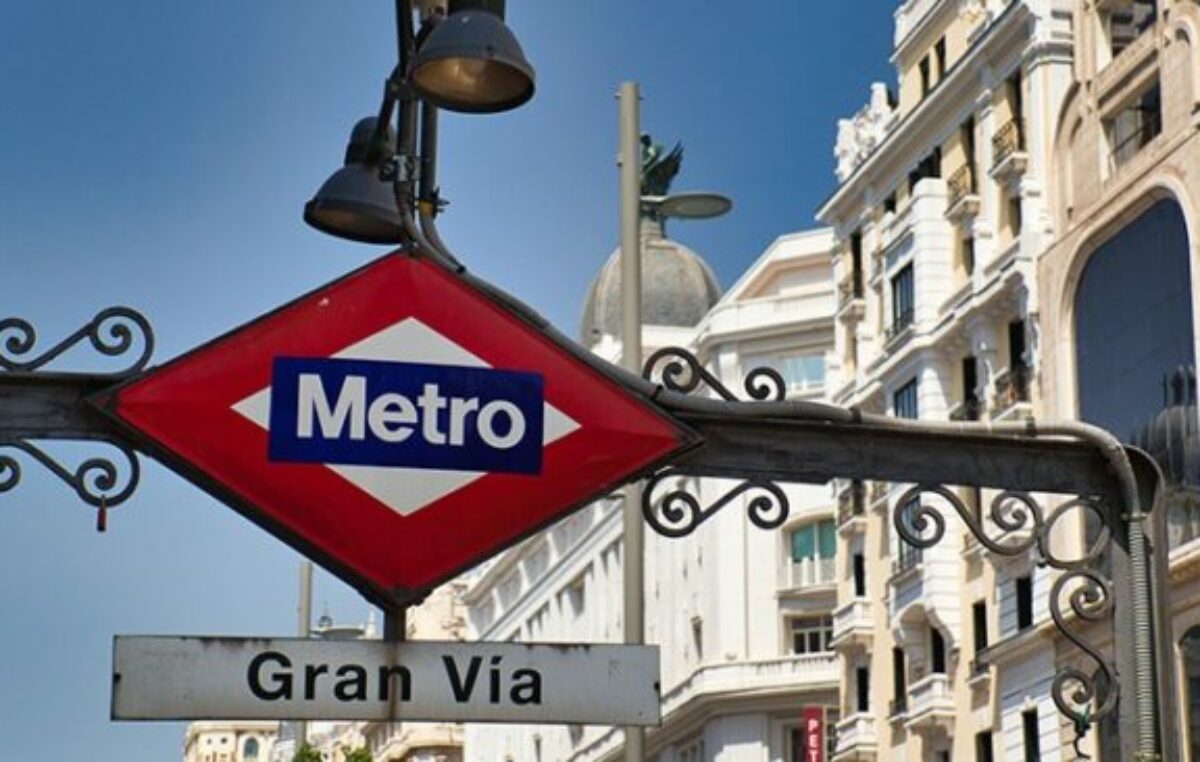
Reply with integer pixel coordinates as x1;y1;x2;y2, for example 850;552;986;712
580;218;721;347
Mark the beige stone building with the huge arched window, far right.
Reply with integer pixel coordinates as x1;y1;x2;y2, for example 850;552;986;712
1038;0;1200;760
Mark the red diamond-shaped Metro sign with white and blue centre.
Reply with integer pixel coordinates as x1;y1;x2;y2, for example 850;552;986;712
97;252;695;604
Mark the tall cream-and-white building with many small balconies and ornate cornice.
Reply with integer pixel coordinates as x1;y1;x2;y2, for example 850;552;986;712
818;0;1074;762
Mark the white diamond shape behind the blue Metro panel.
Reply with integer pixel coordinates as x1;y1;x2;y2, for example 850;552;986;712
233;318;580;516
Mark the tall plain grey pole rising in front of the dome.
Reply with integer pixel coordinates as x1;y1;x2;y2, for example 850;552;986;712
617;82;646;762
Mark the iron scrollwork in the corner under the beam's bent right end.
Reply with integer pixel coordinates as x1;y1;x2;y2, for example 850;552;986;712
892;485;1117;734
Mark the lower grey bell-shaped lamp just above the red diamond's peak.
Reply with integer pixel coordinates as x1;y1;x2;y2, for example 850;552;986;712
304;116;408;244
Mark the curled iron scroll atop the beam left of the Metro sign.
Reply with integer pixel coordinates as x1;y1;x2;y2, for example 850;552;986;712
0;307;154;377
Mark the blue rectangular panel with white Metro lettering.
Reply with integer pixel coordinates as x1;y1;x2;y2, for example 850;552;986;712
269;358;544;474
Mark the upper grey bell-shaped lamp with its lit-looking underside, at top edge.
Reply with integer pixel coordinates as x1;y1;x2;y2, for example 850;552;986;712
412;0;534;114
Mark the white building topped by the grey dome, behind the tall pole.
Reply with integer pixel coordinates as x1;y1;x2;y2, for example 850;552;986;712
464;220;838;762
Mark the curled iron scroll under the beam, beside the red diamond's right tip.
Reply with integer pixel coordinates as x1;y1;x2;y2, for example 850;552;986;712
642;468;791;538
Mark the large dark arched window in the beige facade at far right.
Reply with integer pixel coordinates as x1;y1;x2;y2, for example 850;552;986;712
1075;195;1200;546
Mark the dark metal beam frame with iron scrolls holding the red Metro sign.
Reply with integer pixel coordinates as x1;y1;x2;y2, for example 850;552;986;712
0;250;1178;760
